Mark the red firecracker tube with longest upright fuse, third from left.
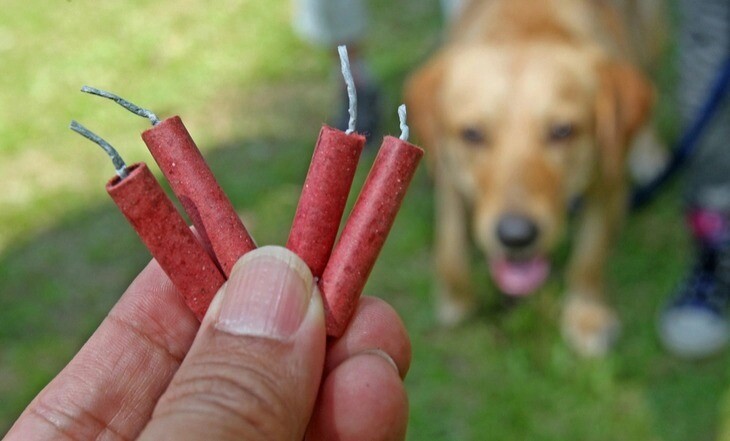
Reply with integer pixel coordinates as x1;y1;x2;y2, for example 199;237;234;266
286;126;365;277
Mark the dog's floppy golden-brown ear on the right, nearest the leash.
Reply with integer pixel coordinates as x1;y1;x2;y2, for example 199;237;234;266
596;62;654;178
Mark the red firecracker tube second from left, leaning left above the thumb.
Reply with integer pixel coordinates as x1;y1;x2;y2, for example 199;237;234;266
142;116;256;276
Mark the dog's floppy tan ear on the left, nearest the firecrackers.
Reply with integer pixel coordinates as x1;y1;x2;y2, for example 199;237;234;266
405;53;446;157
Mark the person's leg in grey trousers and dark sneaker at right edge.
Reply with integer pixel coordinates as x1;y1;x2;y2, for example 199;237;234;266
659;0;730;358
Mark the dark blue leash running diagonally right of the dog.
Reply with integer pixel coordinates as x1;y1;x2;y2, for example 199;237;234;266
630;57;730;210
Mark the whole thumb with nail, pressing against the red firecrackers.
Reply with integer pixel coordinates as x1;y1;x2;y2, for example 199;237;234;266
140;246;326;440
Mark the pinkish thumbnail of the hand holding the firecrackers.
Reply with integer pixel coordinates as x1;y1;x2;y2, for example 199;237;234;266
216;246;314;340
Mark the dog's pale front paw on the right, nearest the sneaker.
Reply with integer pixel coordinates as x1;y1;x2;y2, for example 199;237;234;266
562;296;620;357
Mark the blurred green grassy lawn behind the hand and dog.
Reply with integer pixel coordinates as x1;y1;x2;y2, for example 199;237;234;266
0;0;730;441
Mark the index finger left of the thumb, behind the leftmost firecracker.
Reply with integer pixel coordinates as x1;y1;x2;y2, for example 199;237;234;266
6;260;199;441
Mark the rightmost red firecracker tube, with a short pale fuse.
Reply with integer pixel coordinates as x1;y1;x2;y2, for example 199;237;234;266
319;136;423;337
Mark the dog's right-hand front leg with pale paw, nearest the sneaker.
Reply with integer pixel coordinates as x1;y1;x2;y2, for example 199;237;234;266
562;184;626;356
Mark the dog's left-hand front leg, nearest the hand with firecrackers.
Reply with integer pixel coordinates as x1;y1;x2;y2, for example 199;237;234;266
435;163;476;326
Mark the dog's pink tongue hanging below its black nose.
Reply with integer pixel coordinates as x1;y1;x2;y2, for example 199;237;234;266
490;257;550;296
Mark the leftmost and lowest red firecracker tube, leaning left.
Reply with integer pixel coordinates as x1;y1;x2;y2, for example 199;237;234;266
106;163;225;320
